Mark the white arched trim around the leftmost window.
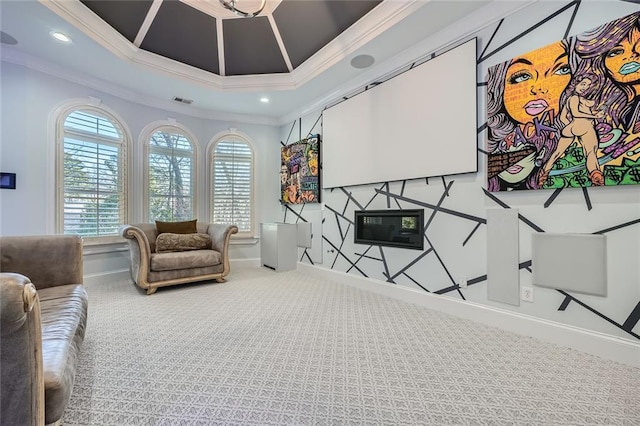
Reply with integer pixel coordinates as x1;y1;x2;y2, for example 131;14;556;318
54;97;133;243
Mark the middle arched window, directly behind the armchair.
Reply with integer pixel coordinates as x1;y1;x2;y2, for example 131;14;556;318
145;125;196;222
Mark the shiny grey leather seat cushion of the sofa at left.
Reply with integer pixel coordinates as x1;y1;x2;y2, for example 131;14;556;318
38;284;89;423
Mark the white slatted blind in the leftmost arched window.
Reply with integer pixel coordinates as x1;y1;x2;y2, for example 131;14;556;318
60;110;126;236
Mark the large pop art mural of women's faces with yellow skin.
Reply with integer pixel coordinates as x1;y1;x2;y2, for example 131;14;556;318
487;12;640;191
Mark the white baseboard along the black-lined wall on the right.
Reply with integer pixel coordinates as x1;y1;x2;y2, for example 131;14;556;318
298;263;640;367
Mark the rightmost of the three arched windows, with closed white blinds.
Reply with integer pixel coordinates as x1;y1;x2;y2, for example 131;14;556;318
209;134;255;237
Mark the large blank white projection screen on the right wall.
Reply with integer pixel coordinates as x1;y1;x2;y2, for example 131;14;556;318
322;38;478;188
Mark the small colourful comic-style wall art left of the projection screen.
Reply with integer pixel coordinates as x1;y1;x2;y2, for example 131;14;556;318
280;135;320;204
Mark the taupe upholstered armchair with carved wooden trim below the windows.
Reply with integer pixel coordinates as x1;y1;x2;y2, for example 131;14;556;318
120;221;238;294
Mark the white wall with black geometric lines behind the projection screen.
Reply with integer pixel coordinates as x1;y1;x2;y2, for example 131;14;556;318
271;1;640;342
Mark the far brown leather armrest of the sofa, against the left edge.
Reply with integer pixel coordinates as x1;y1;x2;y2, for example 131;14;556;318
0;235;83;289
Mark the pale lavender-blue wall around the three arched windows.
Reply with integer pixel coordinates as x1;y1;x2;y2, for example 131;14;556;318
0;62;279;262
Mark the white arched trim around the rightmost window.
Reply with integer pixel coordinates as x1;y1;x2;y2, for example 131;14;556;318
206;129;258;239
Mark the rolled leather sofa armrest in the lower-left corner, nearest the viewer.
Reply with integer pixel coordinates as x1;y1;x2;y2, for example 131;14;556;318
0;273;44;425
